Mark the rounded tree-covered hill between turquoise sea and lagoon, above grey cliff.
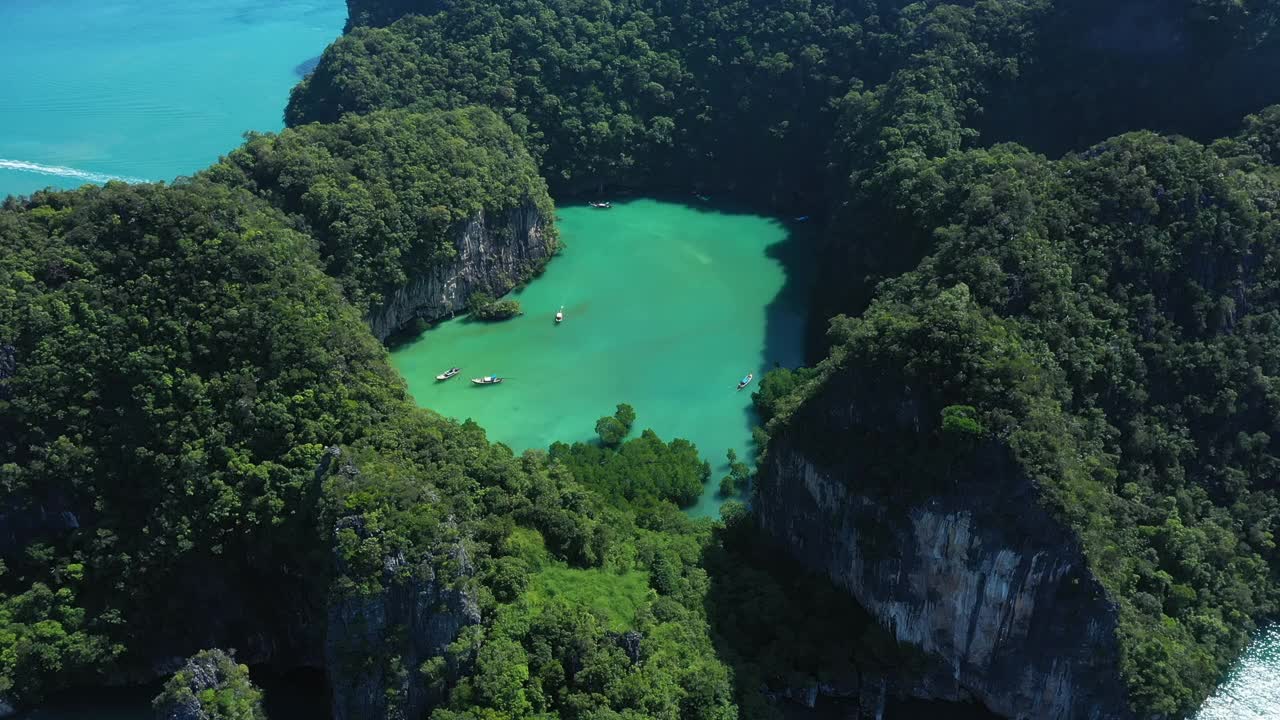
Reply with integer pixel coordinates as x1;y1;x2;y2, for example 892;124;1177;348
206;108;554;310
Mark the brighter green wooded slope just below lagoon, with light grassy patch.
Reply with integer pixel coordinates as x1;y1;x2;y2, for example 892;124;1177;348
329;415;735;720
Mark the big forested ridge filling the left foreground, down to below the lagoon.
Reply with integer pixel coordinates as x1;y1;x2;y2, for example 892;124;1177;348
0;177;735;719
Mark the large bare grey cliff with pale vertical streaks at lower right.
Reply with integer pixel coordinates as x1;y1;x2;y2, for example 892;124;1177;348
756;378;1132;720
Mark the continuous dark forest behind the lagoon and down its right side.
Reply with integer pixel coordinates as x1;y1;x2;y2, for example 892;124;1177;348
289;0;1276;712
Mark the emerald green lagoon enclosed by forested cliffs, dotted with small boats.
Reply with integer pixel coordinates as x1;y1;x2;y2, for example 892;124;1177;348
392;194;808;515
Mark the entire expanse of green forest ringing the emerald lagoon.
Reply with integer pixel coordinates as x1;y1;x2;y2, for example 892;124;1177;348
0;0;1280;720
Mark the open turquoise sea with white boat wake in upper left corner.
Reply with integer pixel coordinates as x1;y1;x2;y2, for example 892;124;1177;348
0;0;347;199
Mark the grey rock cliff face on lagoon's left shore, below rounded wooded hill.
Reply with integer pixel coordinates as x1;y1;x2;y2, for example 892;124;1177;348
366;202;556;340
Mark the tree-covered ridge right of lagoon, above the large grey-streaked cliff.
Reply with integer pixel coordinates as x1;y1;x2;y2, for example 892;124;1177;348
762;117;1280;715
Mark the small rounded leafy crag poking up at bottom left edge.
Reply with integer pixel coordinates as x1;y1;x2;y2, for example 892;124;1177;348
152;650;266;720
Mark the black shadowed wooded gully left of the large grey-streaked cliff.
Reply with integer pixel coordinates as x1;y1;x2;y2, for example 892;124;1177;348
703;514;997;720
